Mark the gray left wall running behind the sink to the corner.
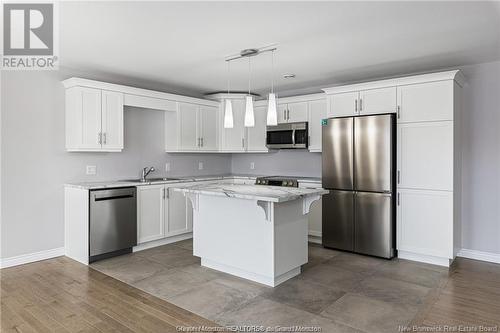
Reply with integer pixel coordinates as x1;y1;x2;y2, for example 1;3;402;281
1;71;231;258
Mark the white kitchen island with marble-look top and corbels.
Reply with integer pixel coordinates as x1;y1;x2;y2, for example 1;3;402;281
174;183;328;287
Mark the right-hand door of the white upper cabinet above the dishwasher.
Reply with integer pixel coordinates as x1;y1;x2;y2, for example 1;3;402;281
101;90;123;150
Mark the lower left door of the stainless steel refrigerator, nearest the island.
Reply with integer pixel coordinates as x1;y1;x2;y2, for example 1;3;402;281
321;191;354;251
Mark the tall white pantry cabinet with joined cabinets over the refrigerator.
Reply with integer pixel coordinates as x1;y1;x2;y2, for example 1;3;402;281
324;71;464;266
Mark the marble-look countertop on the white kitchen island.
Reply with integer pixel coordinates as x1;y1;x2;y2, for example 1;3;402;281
172;184;328;202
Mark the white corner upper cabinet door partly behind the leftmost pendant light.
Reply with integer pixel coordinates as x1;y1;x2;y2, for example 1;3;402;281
221;99;245;151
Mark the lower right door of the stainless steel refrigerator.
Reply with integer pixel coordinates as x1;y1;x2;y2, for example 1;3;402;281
354;192;394;258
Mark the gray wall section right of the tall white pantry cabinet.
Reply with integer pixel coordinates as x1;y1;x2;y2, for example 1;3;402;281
462;62;500;254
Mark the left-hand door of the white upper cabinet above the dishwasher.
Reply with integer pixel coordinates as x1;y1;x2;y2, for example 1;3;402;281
77;88;102;150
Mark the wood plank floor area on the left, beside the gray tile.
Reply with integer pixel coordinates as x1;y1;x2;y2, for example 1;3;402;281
0;257;217;332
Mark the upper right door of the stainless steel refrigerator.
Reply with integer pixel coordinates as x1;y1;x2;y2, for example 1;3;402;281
354;115;393;192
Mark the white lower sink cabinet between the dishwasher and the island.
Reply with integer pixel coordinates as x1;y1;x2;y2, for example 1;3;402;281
137;183;193;244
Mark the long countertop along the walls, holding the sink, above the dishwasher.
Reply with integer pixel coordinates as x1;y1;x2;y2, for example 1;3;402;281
64;174;321;190
